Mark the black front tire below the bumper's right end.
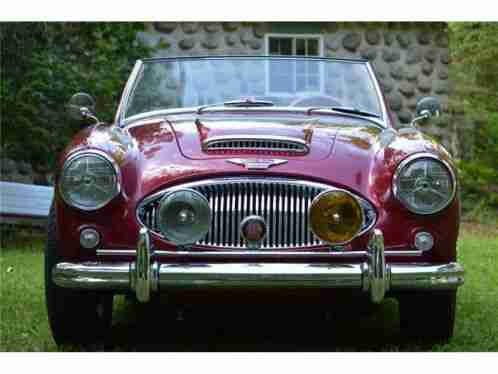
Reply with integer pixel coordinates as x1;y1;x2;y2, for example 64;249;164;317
398;291;456;342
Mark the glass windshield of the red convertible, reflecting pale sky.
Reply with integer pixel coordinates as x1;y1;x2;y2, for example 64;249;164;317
124;57;382;117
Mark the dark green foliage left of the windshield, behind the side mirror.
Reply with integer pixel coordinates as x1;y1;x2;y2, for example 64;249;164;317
0;23;150;171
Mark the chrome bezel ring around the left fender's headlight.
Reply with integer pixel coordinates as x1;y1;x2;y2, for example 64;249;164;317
58;150;121;211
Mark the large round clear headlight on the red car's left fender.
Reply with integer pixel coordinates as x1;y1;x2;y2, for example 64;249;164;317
59;152;119;210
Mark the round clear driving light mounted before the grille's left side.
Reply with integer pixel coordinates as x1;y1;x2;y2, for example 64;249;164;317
157;188;211;245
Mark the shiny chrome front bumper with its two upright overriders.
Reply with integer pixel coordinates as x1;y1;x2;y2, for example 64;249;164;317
52;228;464;303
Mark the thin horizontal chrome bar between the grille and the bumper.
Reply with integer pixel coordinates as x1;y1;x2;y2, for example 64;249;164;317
97;249;424;259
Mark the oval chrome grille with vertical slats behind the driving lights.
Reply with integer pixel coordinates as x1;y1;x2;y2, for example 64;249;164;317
138;177;375;250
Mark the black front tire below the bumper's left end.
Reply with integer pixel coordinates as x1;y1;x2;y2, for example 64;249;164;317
45;204;113;345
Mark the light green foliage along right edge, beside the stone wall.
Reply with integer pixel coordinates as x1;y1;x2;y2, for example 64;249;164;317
449;22;498;217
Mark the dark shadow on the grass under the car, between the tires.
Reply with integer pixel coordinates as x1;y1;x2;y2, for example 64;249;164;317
80;298;442;352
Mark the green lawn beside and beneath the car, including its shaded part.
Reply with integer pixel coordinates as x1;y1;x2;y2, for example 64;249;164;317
0;224;498;351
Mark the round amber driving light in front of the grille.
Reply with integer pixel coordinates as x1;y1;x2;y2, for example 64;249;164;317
309;191;363;245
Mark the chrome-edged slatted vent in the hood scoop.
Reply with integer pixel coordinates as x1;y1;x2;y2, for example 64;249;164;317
202;136;309;154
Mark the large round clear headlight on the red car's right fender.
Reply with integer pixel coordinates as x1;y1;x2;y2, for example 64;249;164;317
393;155;456;214
